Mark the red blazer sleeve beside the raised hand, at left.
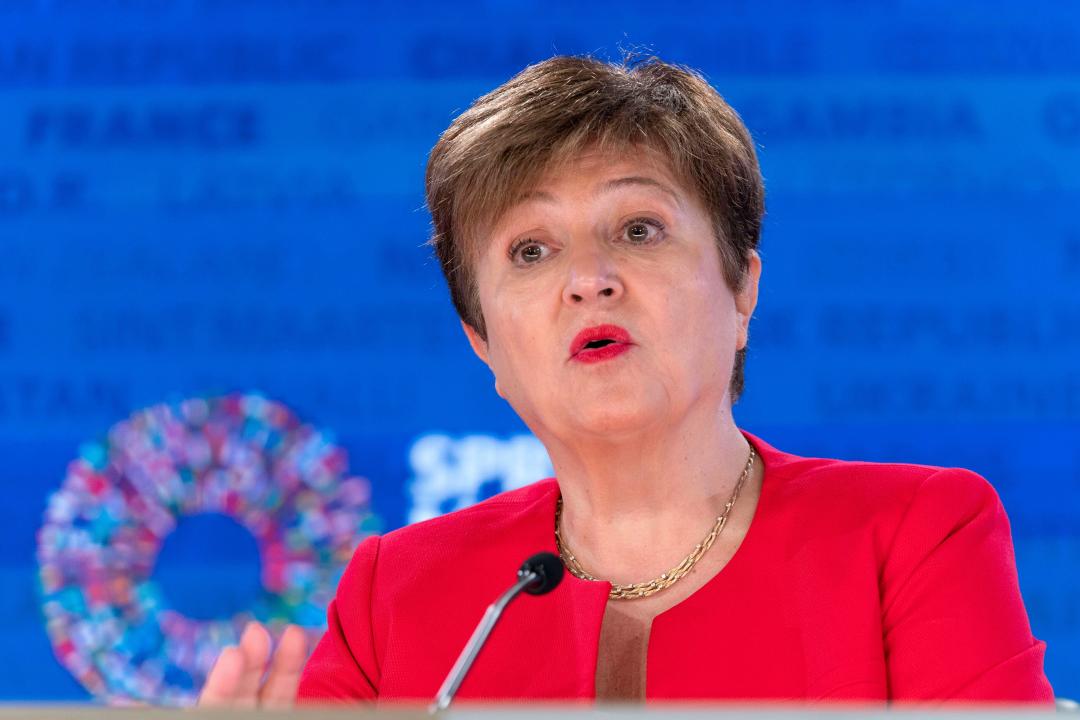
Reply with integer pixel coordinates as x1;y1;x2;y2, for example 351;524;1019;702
297;535;379;704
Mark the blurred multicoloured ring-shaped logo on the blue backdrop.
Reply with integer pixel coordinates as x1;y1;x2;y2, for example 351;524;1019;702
38;394;378;705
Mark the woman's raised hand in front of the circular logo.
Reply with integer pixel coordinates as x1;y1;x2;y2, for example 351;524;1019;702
199;623;308;709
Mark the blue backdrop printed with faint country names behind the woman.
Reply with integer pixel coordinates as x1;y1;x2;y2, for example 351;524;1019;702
0;0;1080;699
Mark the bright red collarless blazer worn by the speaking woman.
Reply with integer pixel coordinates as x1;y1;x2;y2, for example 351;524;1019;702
299;435;1053;703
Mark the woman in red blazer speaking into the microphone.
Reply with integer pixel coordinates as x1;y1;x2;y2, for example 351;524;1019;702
203;57;1052;705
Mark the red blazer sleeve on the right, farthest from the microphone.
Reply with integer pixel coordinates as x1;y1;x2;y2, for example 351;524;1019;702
881;470;1053;703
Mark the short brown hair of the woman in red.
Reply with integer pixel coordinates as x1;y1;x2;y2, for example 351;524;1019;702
427;57;765;400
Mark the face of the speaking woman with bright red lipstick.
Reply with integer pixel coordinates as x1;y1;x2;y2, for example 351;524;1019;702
465;149;760;441
